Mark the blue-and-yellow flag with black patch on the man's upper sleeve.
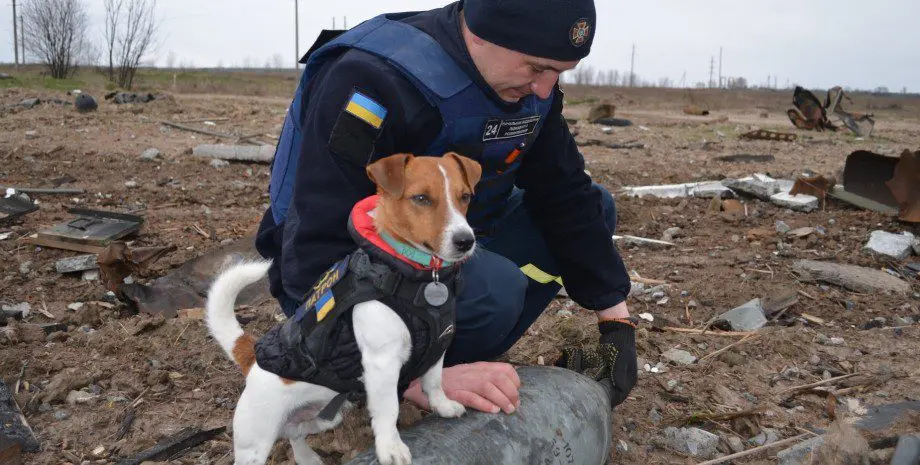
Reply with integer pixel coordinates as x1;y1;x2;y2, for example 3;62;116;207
329;89;387;166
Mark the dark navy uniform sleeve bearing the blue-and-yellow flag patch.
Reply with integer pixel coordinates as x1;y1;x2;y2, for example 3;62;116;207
280;50;438;301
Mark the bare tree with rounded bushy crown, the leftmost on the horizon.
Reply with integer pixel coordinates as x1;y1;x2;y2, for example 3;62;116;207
22;0;89;79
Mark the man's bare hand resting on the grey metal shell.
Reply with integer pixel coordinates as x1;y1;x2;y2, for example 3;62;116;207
404;362;521;414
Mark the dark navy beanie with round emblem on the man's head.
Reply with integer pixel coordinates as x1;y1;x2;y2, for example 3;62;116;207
463;0;596;61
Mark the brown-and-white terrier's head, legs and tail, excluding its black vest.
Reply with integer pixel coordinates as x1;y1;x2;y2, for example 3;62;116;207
206;152;482;465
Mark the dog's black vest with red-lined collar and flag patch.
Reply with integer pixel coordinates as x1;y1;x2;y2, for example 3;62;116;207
256;194;462;419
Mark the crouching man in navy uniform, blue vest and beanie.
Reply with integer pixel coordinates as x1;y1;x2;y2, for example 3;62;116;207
257;0;636;413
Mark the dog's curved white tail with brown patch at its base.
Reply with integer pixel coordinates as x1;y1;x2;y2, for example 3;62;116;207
205;261;271;374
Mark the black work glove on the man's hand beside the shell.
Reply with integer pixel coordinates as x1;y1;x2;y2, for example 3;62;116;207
556;318;638;407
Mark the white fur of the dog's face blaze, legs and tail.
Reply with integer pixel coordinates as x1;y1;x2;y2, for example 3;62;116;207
206;160;475;465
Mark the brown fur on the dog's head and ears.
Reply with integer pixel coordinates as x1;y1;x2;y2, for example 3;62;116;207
367;152;482;254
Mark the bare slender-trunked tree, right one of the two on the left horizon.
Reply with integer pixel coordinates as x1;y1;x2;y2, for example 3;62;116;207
104;0;158;89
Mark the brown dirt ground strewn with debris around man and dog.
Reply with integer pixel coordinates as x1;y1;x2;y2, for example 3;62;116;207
0;73;920;464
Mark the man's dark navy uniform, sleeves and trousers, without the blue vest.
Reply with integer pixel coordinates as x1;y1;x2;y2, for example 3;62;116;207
256;3;630;365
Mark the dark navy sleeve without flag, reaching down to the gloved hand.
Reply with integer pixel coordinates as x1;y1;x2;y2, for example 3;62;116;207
517;88;630;310
